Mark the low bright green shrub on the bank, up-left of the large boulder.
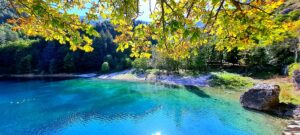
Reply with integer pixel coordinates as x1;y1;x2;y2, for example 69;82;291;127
209;72;253;89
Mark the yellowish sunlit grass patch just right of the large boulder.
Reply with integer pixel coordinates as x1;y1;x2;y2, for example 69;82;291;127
279;83;300;105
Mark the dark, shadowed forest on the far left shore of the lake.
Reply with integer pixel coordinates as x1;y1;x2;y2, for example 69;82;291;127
0;22;131;74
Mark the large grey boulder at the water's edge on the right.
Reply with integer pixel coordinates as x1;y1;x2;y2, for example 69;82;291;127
240;83;280;111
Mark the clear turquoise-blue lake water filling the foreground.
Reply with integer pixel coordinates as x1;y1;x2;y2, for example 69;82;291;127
0;79;284;135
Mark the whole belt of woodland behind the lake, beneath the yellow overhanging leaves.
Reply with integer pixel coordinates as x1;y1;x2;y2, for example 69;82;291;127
0;0;300;74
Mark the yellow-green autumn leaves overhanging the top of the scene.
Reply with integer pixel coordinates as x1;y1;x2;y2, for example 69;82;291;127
4;0;300;60
